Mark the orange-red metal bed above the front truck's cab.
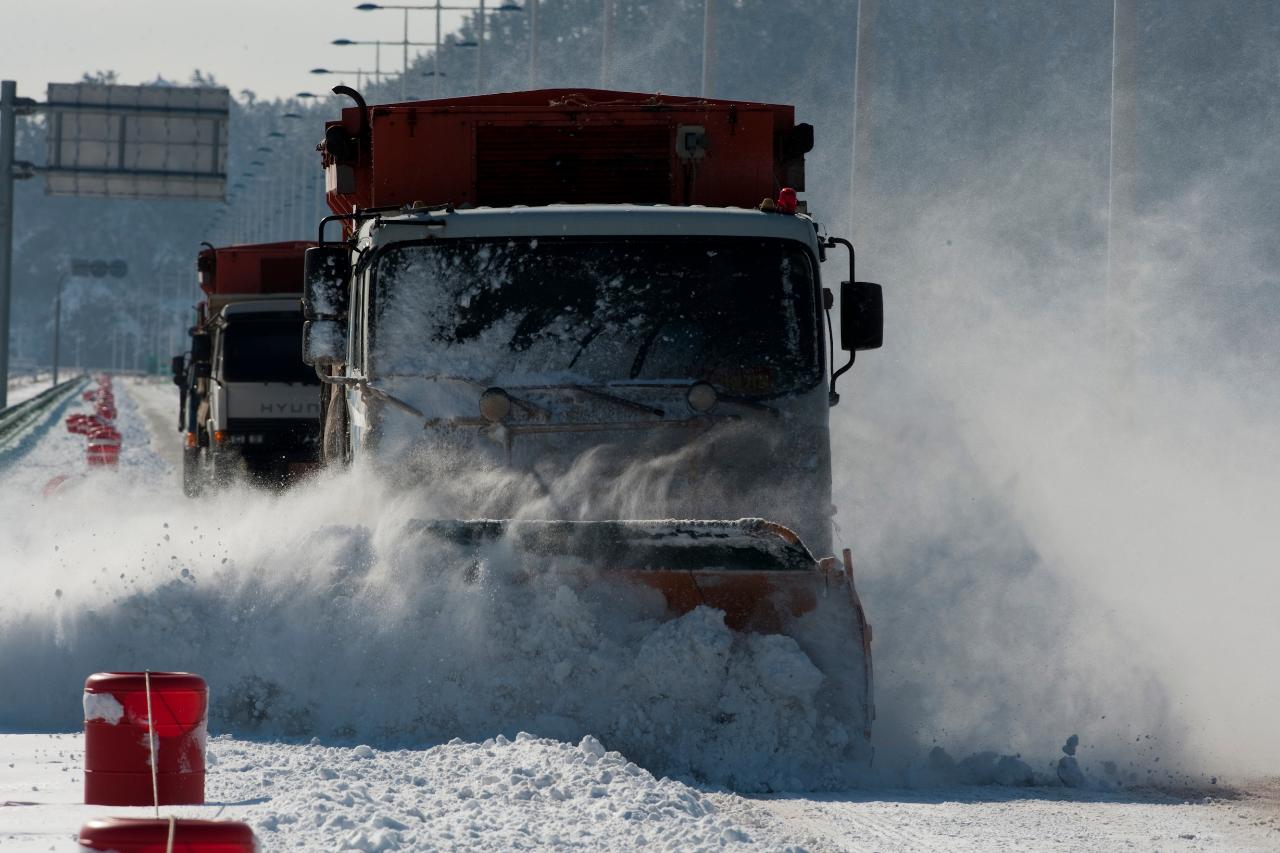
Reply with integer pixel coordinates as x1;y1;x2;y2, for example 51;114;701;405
320;88;813;214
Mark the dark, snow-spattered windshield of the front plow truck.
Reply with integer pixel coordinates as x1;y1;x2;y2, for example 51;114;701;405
370;237;820;396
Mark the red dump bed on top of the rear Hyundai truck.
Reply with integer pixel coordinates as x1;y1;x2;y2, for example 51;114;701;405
196;240;315;310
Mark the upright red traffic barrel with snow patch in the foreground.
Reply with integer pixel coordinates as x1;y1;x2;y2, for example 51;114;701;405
84;672;209;806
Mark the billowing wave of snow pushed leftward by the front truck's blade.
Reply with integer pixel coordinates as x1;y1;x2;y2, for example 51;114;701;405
0;382;865;790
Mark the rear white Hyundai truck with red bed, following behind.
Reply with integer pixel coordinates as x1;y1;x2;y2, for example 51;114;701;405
173;241;320;497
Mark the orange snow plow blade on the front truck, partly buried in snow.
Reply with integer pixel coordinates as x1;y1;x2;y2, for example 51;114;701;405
409;519;874;742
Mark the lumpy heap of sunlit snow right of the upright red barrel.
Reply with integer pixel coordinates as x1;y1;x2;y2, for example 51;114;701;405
210;734;791;850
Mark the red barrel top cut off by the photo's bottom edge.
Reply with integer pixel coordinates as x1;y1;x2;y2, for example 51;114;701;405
79;817;257;853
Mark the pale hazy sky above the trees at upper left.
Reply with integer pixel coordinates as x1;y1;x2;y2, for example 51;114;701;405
0;0;481;100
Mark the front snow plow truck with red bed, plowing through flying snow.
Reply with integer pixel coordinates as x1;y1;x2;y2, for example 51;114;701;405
302;87;883;760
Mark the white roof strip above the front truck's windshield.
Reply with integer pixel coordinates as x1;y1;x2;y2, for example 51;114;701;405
361;205;818;254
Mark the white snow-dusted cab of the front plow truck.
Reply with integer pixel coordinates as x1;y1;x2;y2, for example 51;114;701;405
317;205;832;552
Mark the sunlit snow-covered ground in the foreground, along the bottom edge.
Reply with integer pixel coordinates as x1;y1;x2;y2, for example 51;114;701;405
0;734;1280;852
